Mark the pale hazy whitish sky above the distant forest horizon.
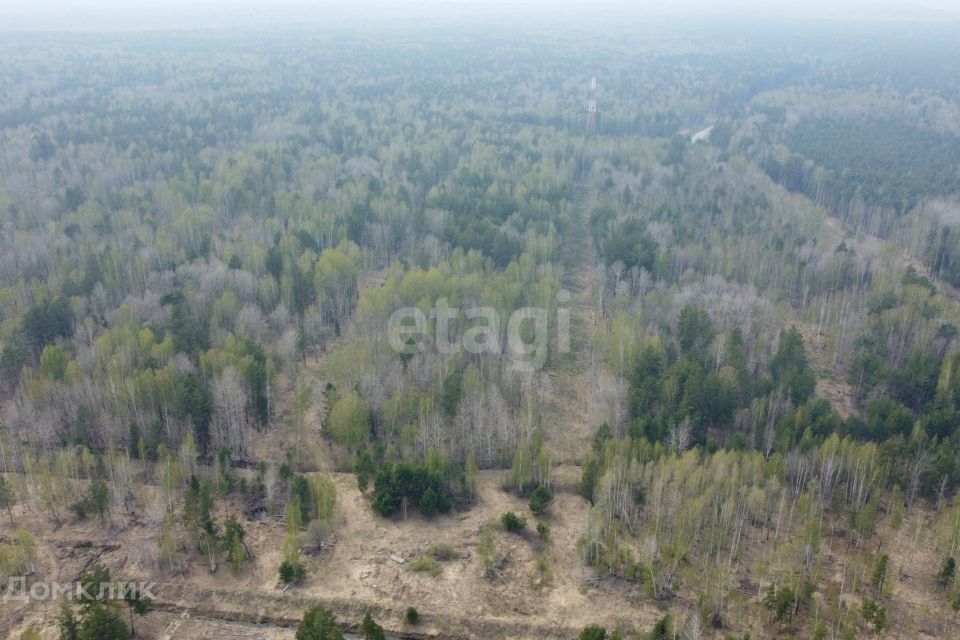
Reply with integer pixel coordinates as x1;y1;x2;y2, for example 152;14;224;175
0;0;960;31
